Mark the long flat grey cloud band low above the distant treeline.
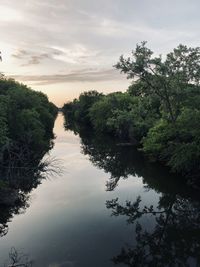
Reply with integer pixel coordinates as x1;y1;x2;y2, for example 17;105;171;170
10;69;122;85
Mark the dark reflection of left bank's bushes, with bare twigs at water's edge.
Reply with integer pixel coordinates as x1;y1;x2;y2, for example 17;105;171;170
0;144;61;241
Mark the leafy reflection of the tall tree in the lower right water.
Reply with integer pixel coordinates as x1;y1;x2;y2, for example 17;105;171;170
106;194;200;266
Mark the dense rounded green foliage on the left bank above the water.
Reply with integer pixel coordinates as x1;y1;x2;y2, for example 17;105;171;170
0;76;57;176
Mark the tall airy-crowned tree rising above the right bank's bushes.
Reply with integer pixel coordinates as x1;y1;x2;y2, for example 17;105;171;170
115;42;200;123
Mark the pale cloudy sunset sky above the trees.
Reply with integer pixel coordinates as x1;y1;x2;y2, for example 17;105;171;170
0;0;200;106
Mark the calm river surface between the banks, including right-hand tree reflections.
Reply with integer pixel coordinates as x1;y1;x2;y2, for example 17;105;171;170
0;115;200;267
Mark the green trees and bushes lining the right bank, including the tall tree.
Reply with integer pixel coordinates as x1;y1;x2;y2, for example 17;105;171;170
63;42;200;182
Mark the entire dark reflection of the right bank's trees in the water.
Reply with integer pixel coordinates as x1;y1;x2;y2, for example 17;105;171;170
66;122;200;267
